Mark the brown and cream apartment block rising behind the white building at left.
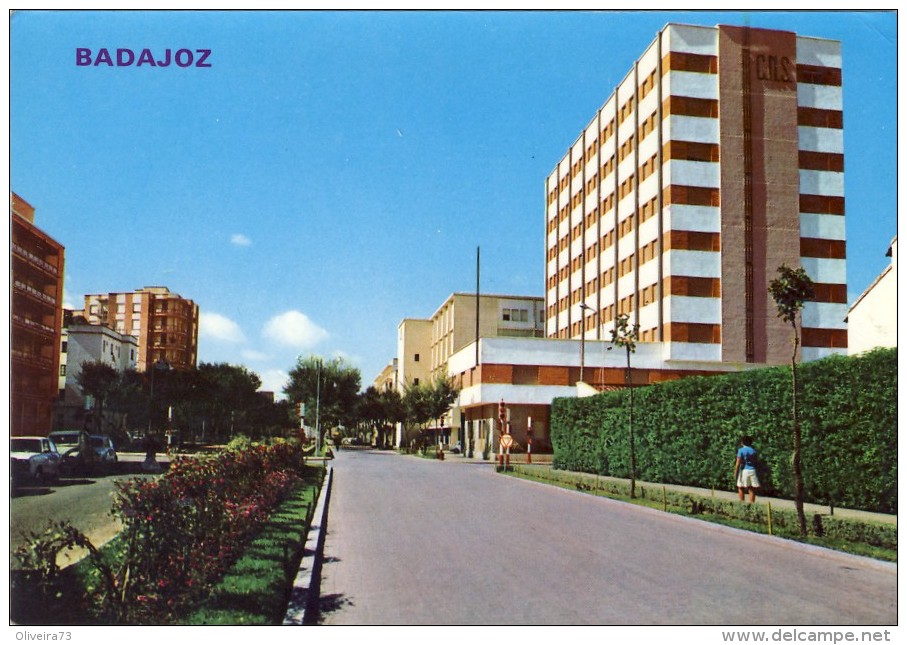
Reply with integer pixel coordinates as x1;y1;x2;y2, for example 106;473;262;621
77;287;198;372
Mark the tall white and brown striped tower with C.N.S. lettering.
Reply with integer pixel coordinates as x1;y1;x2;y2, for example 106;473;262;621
545;25;847;364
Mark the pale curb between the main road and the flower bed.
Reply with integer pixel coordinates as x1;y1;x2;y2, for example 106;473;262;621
283;466;334;625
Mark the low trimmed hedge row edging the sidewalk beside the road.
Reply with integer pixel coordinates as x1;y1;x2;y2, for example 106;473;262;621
513;465;898;551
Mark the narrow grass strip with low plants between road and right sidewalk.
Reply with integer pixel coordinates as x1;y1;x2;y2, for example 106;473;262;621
505;466;898;562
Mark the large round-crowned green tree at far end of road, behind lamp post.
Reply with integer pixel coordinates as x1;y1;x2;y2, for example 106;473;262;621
283;356;362;440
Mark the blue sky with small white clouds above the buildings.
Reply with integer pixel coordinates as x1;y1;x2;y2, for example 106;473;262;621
10;11;898;392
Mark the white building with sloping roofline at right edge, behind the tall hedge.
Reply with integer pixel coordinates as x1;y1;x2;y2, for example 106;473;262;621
847;236;898;354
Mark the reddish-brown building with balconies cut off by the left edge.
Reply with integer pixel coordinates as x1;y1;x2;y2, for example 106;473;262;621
10;193;64;436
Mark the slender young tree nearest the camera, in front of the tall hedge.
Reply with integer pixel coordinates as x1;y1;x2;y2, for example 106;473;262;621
768;264;815;537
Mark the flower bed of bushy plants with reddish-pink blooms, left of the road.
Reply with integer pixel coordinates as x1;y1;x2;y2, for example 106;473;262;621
9;441;316;624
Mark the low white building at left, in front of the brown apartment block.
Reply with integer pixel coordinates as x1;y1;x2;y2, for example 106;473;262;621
54;317;139;430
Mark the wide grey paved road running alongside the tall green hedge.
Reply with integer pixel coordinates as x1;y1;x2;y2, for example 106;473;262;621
320;451;897;625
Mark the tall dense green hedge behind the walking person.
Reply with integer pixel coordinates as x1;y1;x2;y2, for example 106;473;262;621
551;349;897;513
